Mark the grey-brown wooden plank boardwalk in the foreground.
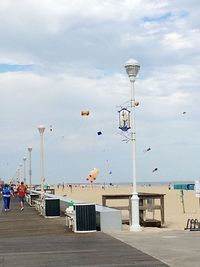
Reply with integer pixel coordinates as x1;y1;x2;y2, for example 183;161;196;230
0;199;167;267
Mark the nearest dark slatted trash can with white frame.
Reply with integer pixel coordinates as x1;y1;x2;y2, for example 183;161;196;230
74;203;96;233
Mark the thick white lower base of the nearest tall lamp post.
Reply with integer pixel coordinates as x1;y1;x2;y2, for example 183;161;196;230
130;192;142;232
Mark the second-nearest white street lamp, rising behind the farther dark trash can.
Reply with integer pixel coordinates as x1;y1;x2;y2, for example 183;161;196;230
38;125;45;199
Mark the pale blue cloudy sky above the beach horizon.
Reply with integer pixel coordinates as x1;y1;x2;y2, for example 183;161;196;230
0;0;200;184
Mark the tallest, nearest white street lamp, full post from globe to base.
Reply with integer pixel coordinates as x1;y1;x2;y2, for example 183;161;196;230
125;59;141;231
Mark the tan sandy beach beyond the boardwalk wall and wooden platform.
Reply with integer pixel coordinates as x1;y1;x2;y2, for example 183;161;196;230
54;185;200;230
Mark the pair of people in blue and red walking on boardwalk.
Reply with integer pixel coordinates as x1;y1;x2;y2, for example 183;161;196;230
2;182;27;211
